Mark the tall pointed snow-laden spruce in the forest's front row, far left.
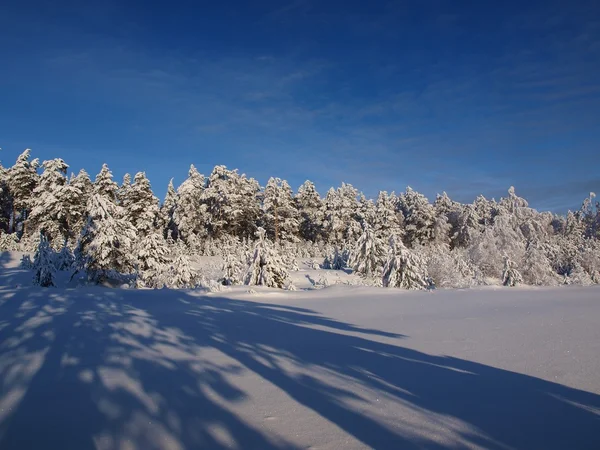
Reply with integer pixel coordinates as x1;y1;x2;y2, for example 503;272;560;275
76;164;136;282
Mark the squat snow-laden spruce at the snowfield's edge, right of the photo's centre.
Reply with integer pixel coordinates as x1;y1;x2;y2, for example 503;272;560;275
382;238;431;290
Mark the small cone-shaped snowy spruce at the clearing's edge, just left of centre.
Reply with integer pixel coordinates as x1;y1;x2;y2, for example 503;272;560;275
244;228;288;289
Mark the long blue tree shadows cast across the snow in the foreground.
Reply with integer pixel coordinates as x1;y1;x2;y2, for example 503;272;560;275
0;289;600;450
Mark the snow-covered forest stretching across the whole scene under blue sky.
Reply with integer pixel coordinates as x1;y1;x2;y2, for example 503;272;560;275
0;149;600;290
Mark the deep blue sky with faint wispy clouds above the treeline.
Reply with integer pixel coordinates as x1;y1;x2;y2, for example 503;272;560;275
0;0;600;212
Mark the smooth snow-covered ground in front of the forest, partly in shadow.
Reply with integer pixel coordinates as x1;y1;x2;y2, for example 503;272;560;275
0;254;600;450
